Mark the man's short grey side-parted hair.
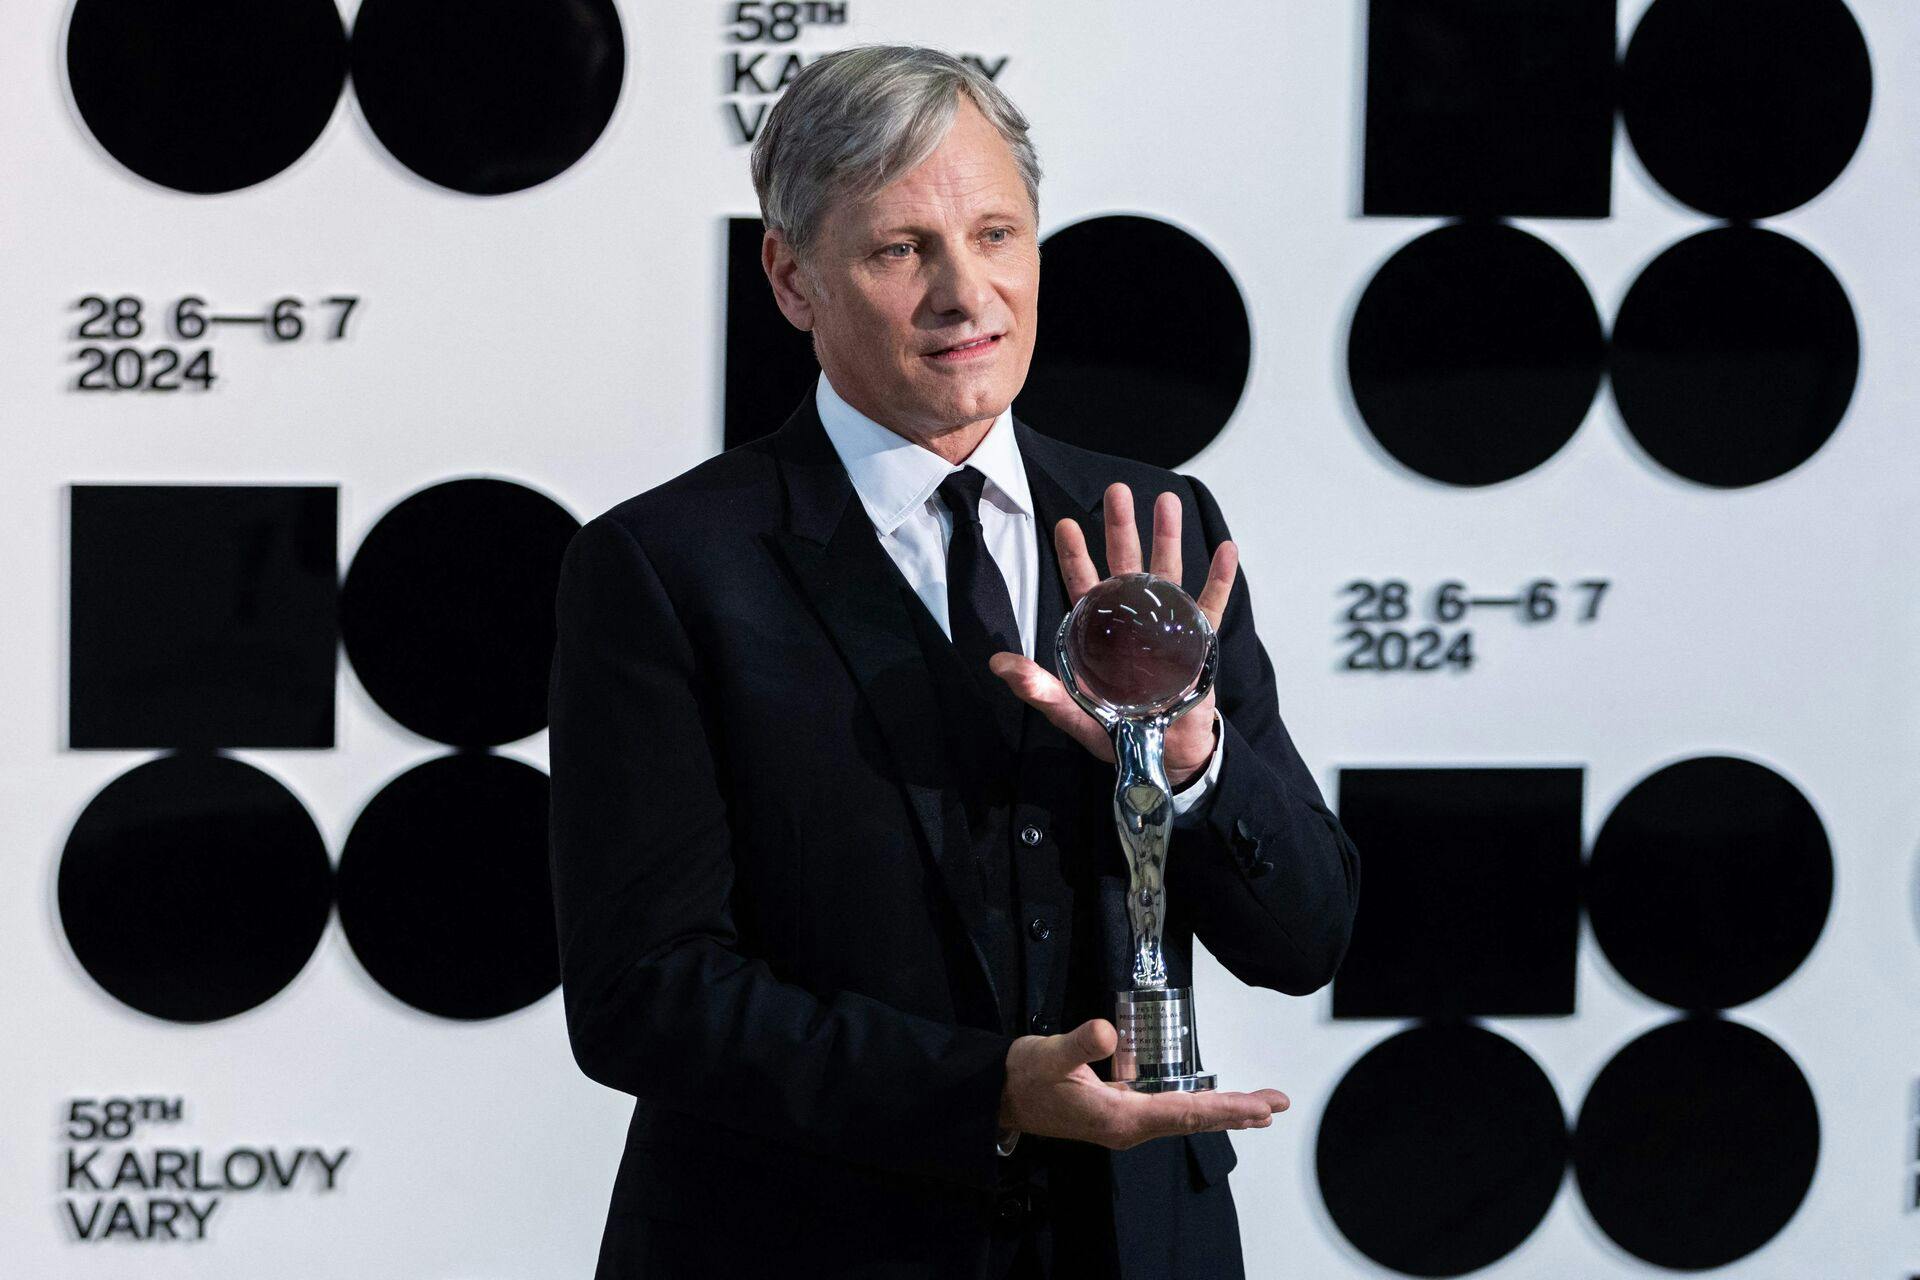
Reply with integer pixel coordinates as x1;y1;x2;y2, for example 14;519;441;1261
751;44;1041;255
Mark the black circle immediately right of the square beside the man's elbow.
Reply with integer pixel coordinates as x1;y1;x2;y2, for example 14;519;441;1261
1586;756;1834;1009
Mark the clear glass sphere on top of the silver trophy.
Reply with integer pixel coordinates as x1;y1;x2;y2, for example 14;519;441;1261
1068;574;1213;718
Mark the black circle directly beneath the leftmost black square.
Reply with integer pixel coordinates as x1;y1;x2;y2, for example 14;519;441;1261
58;752;332;1023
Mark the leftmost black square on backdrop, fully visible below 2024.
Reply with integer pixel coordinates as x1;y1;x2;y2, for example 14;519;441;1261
67;484;340;748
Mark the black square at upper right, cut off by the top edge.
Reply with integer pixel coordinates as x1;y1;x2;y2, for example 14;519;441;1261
1361;0;1617;217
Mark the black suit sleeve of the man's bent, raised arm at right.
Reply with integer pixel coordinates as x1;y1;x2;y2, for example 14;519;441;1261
1167;476;1359;996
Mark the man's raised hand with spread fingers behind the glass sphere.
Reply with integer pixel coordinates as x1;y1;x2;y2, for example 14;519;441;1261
989;484;1240;787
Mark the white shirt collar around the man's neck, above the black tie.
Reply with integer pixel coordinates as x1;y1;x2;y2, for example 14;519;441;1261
814;372;1033;535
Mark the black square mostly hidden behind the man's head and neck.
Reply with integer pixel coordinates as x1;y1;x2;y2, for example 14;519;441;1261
726;217;820;449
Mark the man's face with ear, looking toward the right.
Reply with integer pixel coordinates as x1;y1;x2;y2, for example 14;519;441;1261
764;94;1041;443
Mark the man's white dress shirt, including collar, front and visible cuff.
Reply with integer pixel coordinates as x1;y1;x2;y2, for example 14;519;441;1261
814;374;1227;819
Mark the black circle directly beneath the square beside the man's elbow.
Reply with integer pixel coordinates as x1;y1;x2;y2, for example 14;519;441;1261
1313;1023;1569;1276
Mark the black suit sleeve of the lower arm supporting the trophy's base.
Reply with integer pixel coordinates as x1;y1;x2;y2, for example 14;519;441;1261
549;516;1012;1188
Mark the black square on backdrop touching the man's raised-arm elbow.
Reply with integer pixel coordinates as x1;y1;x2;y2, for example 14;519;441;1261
1332;768;1584;1017
